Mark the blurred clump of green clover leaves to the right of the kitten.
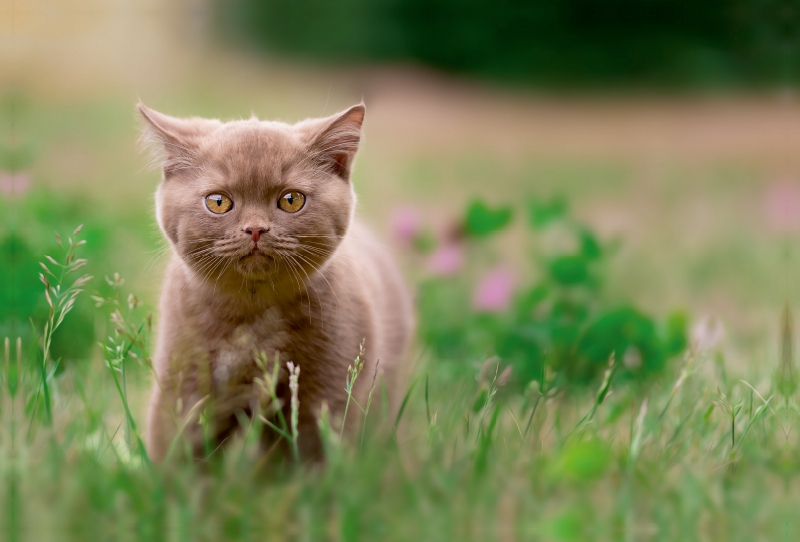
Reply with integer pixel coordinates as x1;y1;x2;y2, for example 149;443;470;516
419;200;687;387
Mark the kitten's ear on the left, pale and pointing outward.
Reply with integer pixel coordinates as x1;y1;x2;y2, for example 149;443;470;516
137;102;211;176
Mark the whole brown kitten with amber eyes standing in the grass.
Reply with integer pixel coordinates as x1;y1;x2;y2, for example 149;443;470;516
139;104;413;461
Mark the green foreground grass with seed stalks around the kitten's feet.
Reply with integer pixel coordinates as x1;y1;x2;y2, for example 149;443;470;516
0;227;798;541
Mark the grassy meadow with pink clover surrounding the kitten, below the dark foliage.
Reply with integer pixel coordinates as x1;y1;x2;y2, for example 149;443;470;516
0;53;800;541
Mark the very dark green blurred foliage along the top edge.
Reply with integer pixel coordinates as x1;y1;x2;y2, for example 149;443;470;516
217;0;800;86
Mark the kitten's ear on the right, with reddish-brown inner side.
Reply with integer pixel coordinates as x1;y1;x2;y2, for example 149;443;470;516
312;103;366;180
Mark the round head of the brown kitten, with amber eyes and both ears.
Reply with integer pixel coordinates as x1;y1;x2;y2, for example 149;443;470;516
139;104;364;287
